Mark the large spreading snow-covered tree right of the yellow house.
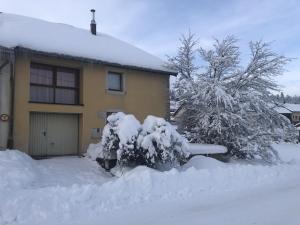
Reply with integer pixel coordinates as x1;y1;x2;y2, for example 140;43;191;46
172;36;295;160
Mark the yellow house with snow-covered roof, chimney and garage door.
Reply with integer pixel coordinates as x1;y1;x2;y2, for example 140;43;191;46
0;11;176;157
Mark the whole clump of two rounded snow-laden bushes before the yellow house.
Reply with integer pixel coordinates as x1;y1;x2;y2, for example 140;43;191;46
94;112;188;168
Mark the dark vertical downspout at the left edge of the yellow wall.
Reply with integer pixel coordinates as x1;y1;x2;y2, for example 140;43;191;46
7;49;16;149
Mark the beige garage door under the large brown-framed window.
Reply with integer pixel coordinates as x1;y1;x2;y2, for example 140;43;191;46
29;113;78;157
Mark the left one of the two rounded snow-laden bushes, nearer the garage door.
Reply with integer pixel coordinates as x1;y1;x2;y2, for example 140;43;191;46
101;112;141;165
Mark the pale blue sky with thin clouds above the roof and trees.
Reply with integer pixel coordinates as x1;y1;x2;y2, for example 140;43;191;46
0;0;300;95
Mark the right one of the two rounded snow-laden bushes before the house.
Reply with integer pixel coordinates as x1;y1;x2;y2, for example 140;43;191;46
138;116;188;168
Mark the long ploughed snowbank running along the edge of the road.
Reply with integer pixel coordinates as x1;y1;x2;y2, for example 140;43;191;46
0;157;300;225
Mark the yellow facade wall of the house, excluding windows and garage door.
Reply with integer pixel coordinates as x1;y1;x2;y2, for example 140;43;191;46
14;54;169;153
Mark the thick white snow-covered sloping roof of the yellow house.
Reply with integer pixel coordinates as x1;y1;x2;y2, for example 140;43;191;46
0;13;176;75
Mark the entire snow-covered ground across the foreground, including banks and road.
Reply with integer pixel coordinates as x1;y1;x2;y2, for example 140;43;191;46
0;144;300;225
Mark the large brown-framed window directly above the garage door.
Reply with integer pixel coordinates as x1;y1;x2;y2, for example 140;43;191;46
30;63;79;105
